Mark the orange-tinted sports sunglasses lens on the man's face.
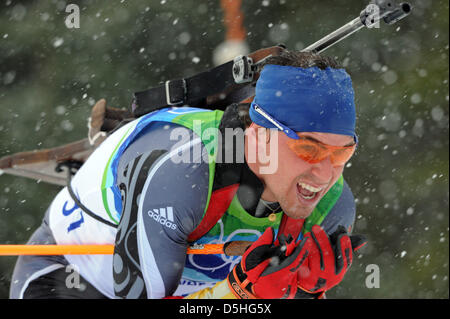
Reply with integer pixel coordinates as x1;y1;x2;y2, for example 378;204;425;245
287;136;356;166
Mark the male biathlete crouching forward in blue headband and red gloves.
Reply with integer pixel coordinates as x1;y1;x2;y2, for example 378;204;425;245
10;51;365;299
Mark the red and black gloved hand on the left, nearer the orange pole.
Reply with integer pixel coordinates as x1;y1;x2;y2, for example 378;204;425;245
228;227;311;299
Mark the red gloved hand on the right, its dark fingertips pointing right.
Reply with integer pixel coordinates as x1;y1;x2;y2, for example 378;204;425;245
298;225;367;293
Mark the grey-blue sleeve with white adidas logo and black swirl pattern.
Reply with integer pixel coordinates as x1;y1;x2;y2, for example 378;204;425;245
113;123;209;299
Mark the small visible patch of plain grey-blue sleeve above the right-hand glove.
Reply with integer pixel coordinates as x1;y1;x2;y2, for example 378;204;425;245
321;181;356;234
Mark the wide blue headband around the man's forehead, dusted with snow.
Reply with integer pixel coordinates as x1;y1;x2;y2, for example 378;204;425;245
250;64;357;140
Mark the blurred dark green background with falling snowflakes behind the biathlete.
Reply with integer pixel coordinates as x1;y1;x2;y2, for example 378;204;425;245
0;0;449;298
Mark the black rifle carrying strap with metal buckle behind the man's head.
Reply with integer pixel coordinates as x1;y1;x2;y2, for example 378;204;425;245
131;46;284;117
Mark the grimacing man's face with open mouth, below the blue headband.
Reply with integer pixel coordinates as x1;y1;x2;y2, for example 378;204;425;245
246;124;353;218
